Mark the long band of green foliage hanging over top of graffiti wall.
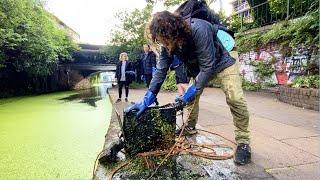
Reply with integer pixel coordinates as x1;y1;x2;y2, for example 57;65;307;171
236;12;319;52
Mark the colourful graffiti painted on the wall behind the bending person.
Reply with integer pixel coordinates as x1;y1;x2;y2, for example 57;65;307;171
239;45;310;85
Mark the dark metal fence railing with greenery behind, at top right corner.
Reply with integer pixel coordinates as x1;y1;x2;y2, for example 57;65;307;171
237;0;319;29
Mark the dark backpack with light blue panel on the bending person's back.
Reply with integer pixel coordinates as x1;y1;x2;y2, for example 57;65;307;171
175;0;235;52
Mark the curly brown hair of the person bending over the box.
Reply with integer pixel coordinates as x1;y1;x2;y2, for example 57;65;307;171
146;11;191;52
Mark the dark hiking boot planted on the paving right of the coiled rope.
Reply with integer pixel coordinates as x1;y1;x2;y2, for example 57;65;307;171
234;143;251;165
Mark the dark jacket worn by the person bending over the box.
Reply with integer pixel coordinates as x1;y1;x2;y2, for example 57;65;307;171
149;18;235;94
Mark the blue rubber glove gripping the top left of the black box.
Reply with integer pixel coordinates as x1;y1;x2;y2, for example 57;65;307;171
124;90;156;116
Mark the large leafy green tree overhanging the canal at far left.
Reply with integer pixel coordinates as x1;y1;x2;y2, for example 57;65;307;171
0;0;77;96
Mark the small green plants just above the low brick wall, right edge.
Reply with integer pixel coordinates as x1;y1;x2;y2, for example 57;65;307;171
292;75;320;88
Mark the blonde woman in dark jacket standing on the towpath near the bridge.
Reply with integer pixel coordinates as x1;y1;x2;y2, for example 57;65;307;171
116;52;134;102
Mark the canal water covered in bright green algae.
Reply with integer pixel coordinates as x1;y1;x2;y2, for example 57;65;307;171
0;87;112;179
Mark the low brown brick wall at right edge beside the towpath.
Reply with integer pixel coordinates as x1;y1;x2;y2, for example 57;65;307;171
278;86;319;111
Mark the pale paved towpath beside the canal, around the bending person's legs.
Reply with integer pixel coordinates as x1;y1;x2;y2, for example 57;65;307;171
119;88;320;179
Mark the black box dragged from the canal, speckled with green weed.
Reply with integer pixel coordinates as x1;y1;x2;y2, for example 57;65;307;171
123;106;176;157
